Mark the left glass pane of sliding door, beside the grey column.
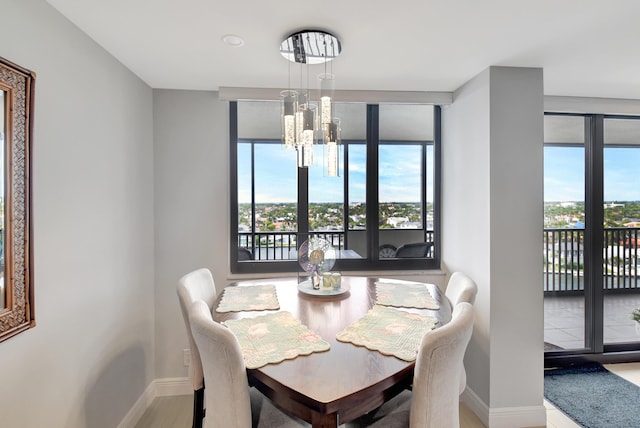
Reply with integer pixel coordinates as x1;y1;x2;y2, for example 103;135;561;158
543;116;586;351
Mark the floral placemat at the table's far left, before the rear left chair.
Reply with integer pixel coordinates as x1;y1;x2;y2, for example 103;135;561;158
216;285;280;312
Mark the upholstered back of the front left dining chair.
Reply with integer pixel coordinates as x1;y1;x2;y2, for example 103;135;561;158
189;300;252;428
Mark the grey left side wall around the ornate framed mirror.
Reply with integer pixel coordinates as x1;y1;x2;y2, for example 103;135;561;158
0;0;155;428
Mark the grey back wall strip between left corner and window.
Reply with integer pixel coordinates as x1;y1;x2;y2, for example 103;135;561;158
153;90;229;378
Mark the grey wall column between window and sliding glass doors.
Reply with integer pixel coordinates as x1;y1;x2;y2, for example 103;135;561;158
443;67;545;427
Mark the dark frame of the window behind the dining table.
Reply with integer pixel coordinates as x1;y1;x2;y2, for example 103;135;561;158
229;101;442;274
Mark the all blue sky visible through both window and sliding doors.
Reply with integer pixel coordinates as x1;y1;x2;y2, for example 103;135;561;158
238;144;640;203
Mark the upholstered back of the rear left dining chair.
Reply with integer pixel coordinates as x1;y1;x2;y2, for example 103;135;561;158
177;268;217;391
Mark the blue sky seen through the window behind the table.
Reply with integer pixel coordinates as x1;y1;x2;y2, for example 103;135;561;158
238;144;433;203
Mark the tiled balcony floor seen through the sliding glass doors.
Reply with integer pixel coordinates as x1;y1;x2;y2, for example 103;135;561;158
544;291;640;350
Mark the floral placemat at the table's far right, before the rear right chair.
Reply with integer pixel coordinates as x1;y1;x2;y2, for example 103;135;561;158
376;280;440;311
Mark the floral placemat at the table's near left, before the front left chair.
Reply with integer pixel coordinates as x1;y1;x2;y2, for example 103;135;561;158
223;311;330;369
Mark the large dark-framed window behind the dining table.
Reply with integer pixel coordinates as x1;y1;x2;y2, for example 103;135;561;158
230;101;440;273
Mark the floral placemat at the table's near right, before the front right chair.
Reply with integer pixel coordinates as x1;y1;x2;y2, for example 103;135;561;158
336;305;438;361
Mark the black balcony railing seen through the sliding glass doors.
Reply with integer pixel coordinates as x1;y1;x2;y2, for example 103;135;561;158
543;227;640;292
